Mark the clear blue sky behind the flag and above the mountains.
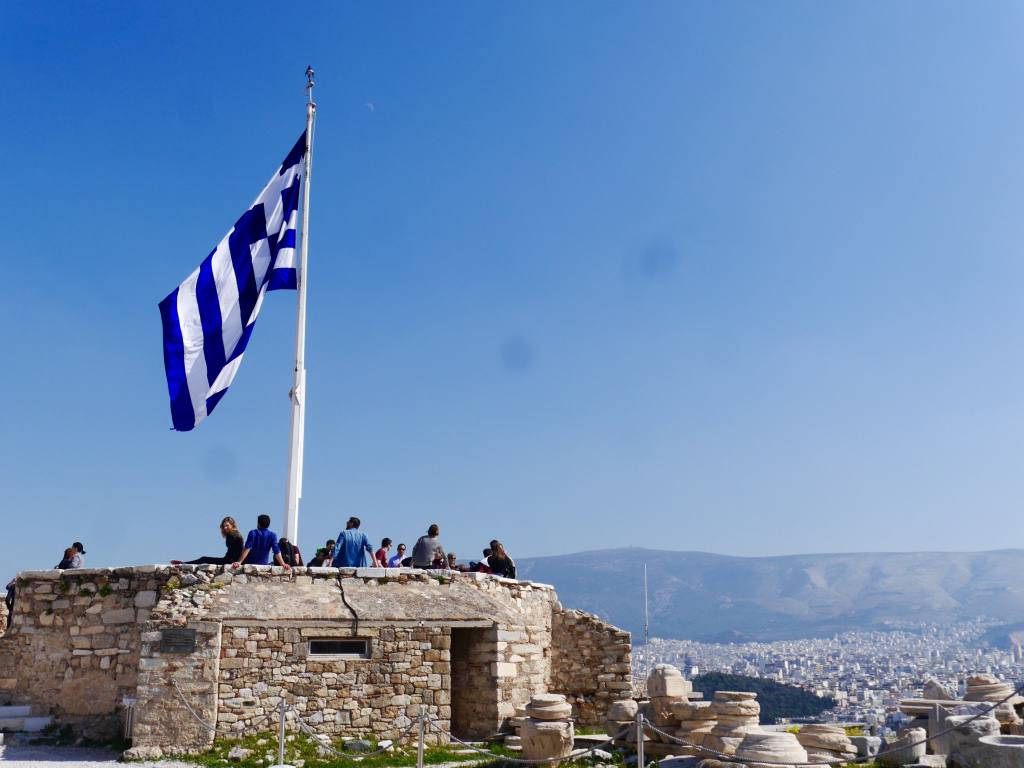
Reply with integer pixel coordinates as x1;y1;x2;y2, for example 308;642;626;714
0;1;1024;573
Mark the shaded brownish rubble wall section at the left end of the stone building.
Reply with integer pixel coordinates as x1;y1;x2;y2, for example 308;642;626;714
0;567;165;738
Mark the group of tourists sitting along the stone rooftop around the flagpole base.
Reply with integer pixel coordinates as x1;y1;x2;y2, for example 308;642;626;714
172;515;516;579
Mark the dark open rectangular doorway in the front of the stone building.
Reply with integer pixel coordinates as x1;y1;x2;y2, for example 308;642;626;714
451;628;501;739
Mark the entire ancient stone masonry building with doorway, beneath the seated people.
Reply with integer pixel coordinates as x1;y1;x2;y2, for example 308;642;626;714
0;566;630;757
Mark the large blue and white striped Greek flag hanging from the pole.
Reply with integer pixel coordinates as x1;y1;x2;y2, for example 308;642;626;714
160;133;306;431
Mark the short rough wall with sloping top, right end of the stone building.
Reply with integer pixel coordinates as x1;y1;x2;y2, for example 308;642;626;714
551;606;633;725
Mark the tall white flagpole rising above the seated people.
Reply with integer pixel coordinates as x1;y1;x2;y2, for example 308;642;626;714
284;67;316;544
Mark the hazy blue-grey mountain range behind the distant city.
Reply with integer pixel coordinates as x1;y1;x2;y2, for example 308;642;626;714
518;548;1024;642
